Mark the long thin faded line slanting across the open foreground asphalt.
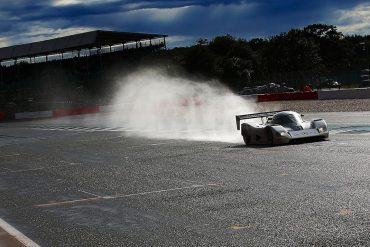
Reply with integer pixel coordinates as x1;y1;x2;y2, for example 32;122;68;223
34;184;217;208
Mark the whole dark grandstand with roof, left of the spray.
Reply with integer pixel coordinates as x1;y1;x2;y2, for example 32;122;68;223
0;30;167;112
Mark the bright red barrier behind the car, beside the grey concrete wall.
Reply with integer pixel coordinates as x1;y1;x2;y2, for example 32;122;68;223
257;92;318;102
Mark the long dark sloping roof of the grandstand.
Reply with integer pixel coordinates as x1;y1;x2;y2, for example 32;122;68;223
0;30;167;61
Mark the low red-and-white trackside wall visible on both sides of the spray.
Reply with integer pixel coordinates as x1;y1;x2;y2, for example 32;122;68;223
0;88;370;121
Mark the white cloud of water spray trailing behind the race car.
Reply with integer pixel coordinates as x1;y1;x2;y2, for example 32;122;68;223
110;69;256;143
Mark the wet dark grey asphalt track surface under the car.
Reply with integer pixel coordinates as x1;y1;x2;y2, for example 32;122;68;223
0;112;370;246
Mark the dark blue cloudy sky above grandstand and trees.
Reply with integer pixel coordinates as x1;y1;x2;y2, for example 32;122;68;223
0;0;370;47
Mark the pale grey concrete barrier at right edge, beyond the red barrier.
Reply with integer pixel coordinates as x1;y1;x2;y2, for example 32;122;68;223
318;88;370;100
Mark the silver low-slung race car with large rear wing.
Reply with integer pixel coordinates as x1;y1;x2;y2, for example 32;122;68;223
236;110;329;146
